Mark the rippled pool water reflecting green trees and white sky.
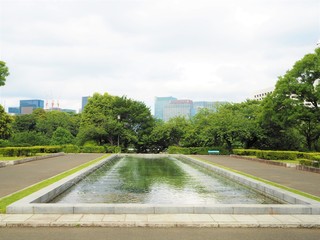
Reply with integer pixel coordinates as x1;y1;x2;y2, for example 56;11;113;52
52;157;278;204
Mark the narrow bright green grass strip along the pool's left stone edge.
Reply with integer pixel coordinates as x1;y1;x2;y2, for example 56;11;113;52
0;154;110;213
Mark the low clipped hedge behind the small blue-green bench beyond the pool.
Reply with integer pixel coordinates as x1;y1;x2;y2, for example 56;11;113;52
167;146;228;155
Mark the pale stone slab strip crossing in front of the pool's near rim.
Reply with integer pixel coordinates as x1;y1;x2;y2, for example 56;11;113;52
0;214;320;227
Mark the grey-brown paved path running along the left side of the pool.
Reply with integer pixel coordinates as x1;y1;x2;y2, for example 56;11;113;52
0;153;103;198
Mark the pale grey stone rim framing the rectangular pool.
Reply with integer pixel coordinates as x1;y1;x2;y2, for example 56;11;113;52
7;154;320;215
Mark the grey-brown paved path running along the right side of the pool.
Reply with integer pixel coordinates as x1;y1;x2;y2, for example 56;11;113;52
196;155;320;197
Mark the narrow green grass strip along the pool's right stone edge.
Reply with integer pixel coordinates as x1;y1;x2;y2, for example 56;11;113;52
197;158;320;202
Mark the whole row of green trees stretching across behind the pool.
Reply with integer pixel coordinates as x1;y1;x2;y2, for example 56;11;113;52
0;49;320;152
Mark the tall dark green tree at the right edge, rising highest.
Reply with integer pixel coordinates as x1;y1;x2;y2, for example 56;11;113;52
266;48;320;150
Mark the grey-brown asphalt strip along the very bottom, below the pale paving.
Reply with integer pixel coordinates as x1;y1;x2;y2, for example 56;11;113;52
0;227;320;240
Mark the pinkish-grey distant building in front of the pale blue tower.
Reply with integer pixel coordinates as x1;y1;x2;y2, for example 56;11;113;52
163;100;193;121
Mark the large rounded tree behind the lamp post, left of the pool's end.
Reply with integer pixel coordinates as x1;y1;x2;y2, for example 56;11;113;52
77;93;154;151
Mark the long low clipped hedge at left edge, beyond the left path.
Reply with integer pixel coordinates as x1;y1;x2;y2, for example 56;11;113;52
0;146;62;157
